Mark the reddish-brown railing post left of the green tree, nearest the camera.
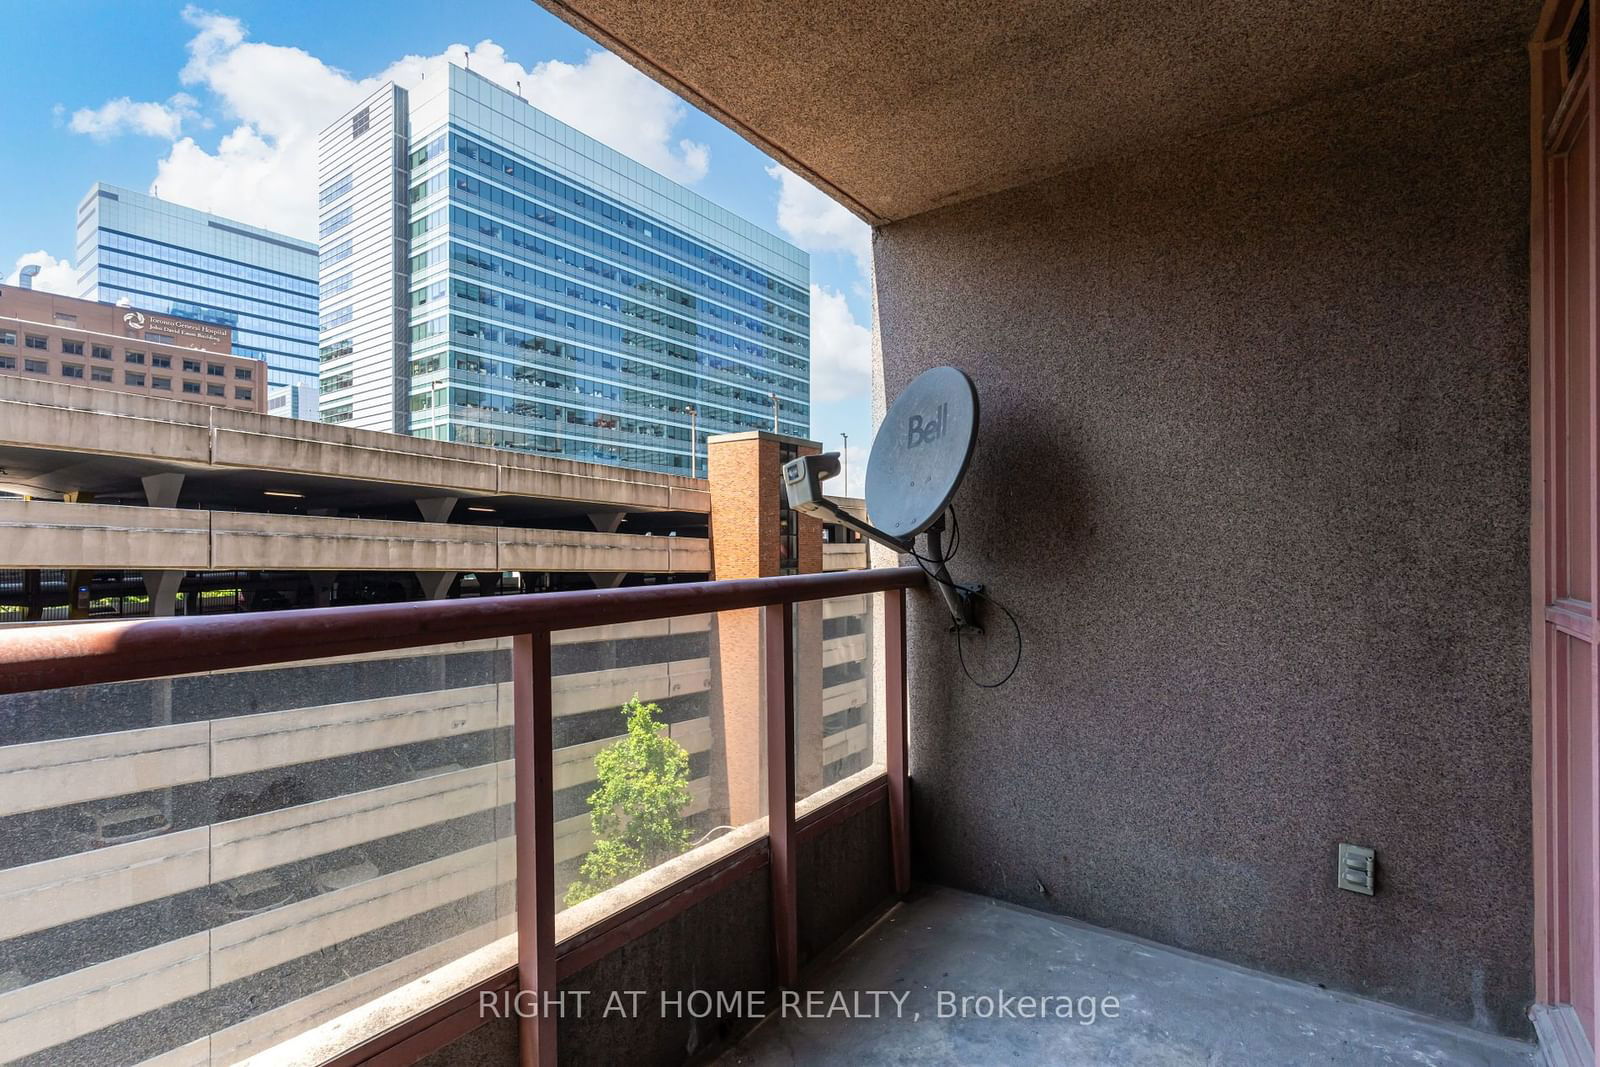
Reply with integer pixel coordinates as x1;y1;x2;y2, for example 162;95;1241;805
512;630;560;1067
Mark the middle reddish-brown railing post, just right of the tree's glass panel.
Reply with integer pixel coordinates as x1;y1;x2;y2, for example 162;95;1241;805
762;601;800;989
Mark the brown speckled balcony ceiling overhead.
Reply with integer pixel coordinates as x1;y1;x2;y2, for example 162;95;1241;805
539;0;1538;224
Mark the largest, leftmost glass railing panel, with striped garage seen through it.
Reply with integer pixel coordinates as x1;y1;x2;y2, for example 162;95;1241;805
0;641;515;1065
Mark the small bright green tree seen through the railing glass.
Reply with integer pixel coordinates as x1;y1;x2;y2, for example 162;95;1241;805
566;693;690;905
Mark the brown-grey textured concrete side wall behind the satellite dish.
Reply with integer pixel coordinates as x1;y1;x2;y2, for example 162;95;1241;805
875;51;1533;1033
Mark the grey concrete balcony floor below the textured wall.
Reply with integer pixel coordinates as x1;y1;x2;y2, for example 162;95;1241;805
717;888;1536;1067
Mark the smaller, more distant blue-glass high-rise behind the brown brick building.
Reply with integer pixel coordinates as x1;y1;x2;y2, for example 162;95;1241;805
75;182;317;404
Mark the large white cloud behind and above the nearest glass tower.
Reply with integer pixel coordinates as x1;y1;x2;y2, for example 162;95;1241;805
74;6;710;238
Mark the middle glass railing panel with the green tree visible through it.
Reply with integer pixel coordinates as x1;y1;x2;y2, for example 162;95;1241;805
552;609;766;936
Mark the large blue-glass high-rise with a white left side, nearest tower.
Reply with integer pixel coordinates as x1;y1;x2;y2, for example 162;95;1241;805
318;66;810;475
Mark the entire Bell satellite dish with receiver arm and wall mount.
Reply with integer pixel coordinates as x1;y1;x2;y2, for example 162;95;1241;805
782;366;982;633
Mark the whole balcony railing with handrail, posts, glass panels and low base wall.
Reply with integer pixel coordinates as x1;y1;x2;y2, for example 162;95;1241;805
0;569;922;1065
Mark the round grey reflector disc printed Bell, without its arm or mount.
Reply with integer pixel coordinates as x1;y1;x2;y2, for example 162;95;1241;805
867;366;978;541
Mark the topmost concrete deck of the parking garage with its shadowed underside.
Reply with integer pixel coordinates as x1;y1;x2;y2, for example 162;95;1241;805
0;376;710;522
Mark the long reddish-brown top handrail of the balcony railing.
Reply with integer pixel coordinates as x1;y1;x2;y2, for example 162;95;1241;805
0;566;926;694
